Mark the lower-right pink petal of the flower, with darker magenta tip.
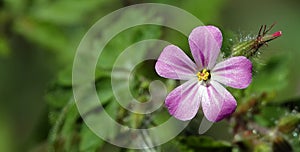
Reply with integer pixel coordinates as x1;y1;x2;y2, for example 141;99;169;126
201;81;237;122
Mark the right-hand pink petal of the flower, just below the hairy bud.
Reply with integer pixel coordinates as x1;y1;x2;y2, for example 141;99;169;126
211;56;252;89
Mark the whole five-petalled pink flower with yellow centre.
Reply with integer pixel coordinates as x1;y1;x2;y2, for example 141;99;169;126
155;26;252;122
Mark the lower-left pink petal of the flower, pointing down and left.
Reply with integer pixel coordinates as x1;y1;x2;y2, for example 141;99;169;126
165;79;204;121
